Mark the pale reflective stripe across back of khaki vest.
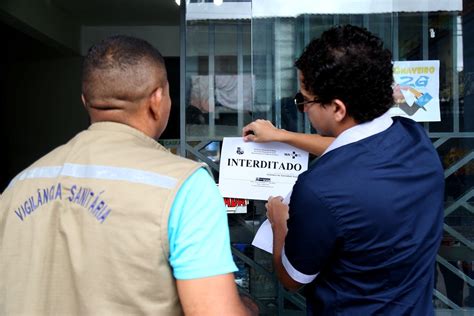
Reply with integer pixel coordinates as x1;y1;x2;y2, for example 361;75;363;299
8;163;177;189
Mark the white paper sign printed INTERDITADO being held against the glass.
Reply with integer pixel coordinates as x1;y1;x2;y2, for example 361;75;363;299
219;137;308;200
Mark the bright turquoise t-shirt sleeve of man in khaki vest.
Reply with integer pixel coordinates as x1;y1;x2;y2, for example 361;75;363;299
168;168;237;280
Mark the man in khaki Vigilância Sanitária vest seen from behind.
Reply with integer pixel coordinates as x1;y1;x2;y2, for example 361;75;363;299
0;36;254;315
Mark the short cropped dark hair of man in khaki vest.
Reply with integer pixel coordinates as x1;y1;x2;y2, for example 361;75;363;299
82;35;167;102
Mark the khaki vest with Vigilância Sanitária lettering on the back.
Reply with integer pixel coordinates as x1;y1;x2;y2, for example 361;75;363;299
0;122;201;315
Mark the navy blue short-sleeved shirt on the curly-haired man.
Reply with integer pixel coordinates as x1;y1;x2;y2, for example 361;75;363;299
283;117;444;316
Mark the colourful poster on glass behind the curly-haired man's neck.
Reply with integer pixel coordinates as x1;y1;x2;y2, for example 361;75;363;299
389;60;441;122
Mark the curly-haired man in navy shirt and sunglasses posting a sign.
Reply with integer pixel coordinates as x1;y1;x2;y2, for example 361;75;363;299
267;25;444;315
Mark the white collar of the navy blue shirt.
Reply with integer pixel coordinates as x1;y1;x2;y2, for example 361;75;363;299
321;111;393;156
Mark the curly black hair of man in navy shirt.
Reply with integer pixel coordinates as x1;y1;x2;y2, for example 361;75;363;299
295;25;393;123
